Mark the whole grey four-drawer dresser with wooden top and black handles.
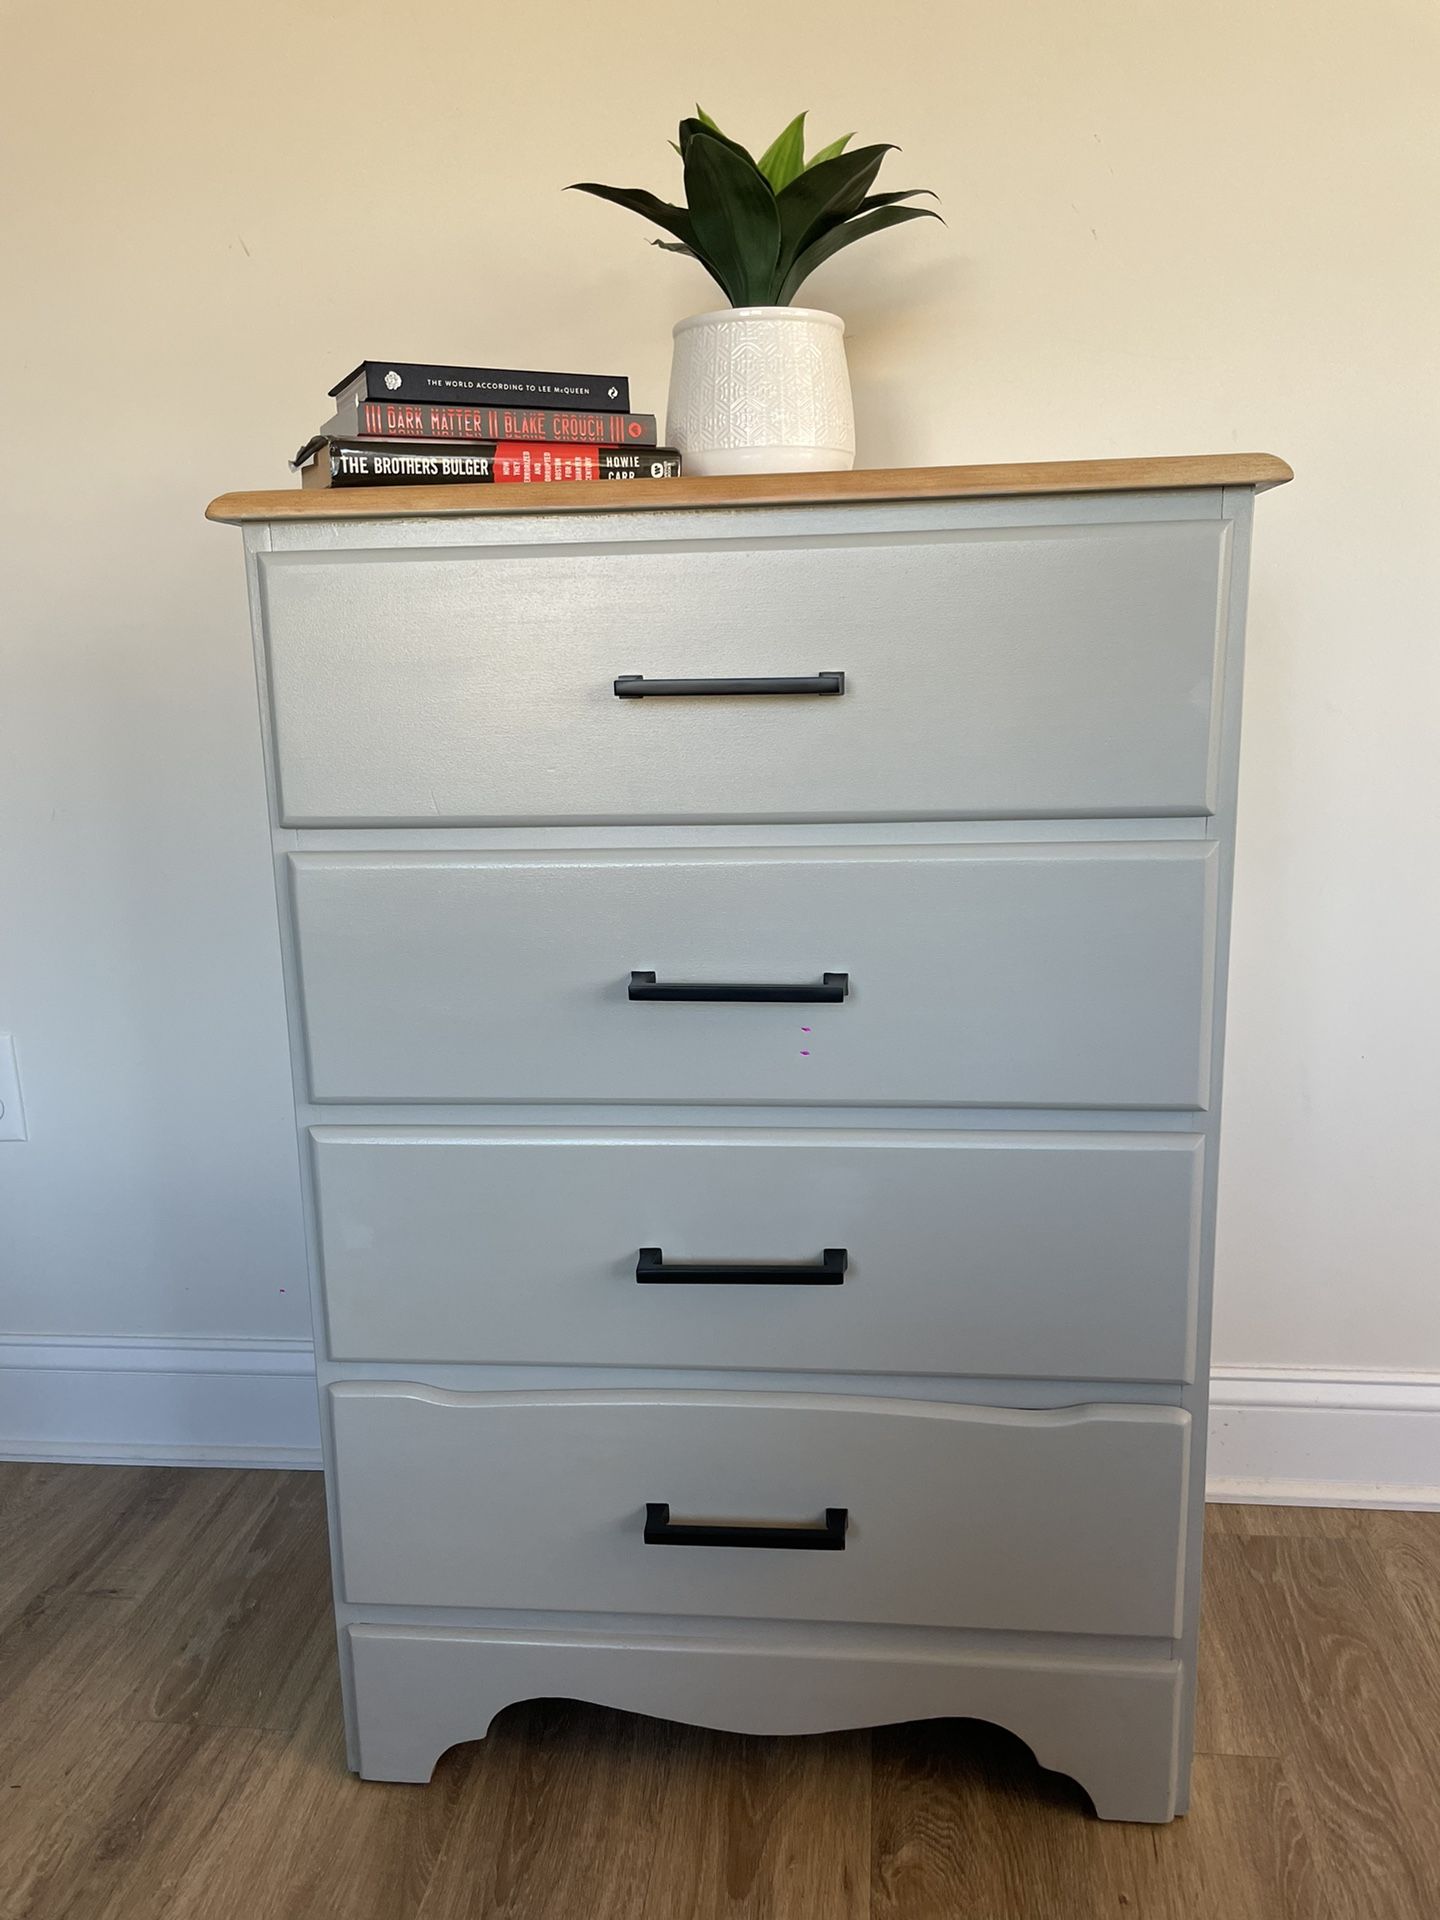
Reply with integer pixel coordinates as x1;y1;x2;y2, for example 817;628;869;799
209;455;1290;1820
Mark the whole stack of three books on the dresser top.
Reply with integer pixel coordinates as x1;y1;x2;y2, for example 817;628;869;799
290;361;680;486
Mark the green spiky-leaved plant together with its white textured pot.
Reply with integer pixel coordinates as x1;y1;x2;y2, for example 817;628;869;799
574;108;939;474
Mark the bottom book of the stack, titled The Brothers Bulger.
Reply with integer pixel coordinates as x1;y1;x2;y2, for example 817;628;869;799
290;434;680;486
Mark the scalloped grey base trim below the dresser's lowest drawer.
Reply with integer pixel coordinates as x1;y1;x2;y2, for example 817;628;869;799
348;1626;1185;1822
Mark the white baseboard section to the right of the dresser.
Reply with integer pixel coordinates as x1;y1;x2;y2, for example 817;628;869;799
1206;1367;1440;1509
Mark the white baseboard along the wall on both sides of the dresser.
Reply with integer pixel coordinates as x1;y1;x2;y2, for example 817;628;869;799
0;1334;1440;1509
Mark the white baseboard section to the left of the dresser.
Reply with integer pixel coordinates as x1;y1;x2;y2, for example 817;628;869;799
0;1334;321;1467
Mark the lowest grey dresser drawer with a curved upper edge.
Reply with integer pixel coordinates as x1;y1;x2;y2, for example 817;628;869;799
330;1382;1188;1636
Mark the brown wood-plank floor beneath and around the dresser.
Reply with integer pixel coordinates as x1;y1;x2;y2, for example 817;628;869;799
0;1465;1440;1920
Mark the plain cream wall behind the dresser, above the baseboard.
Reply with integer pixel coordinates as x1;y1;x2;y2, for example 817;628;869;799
0;0;1440;1369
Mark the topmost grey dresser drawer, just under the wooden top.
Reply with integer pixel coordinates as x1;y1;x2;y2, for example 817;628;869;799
259;515;1229;828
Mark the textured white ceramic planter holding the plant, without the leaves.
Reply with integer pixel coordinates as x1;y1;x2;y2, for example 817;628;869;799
666;307;854;474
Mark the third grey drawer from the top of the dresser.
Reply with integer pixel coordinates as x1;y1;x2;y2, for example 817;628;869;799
311;1127;1204;1380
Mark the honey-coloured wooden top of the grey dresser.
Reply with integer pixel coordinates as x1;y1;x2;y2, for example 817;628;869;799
205;453;1294;524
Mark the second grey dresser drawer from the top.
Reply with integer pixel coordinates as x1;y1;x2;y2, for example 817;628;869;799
290;841;1217;1108
